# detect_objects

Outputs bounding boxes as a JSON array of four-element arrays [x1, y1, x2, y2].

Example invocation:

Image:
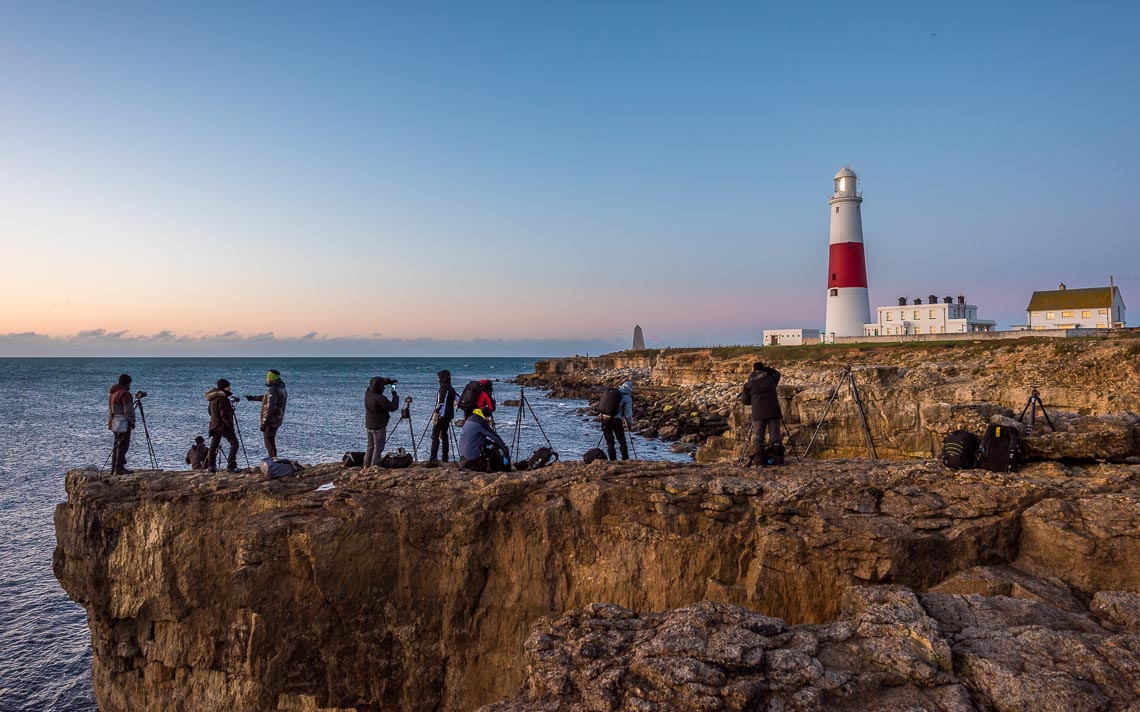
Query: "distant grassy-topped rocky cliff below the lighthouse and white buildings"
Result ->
[[520, 330, 1140, 463]]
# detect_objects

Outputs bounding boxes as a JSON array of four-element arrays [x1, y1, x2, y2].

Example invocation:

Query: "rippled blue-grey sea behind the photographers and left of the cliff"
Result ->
[[0, 358, 687, 712]]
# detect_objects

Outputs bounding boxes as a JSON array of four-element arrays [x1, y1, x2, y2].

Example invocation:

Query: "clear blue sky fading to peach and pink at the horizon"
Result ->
[[0, 1, 1140, 355]]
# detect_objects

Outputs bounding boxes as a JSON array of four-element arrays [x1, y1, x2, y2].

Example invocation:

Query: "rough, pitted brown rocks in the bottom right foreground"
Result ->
[[482, 587, 1140, 712]]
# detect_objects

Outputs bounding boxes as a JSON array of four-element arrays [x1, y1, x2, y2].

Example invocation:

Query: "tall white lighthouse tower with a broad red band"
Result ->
[[824, 166, 871, 341]]
